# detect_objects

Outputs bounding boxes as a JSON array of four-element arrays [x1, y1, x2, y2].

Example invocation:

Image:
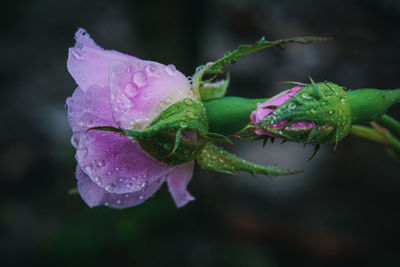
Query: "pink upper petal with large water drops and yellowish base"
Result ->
[[110, 59, 194, 129]]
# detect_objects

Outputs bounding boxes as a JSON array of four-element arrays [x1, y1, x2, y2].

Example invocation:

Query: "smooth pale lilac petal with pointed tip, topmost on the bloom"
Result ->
[[67, 29, 135, 91]]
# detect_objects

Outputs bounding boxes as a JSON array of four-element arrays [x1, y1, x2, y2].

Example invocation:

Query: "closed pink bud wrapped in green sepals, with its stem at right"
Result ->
[[251, 80, 400, 149]]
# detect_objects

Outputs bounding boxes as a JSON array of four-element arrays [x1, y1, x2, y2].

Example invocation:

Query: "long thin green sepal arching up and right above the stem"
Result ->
[[192, 36, 332, 100]]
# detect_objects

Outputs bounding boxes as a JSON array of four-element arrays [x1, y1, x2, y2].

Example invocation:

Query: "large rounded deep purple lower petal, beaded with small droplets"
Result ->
[[76, 130, 174, 194]]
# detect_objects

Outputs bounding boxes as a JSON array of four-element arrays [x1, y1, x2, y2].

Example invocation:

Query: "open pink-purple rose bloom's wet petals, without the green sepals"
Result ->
[[67, 29, 194, 209]]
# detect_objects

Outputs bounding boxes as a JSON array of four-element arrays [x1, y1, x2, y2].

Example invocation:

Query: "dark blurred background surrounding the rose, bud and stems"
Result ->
[[0, 0, 400, 266]]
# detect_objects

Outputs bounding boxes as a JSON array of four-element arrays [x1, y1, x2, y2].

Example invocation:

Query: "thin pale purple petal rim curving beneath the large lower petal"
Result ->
[[76, 165, 165, 209]]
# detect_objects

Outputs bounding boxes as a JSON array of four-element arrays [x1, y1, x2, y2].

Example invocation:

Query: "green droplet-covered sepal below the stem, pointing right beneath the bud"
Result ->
[[196, 142, 300, 176]]
